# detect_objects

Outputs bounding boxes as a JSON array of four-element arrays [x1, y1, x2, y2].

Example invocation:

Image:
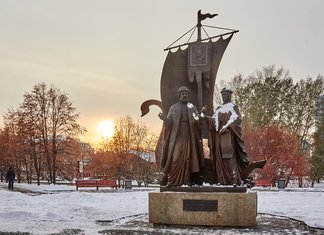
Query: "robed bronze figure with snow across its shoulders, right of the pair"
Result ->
[[208, 88, 265, 185]]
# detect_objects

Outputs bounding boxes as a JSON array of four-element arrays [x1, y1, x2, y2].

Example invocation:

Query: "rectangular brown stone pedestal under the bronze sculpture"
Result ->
[[149, 192, 257, 227]]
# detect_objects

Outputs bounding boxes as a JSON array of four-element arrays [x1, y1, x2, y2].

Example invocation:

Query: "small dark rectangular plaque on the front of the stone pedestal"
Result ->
[[183, 199, 218, 211]]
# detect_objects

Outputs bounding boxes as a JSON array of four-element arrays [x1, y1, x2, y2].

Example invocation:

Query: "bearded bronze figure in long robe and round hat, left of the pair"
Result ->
[[158, 86, 204, 186]]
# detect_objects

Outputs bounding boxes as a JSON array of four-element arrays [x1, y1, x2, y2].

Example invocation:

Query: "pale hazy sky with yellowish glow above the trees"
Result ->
[[0, 0, 324, 142]]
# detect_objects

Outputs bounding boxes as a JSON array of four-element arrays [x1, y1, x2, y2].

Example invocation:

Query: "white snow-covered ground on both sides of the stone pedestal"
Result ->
[[0, 183, 324, 234]]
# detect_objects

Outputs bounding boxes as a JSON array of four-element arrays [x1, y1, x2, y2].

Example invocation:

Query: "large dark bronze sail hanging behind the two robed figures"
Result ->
[[160, 34, 233, 119]]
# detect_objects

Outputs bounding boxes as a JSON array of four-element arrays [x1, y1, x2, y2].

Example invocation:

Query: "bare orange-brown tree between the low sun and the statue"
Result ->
[[90, 116, 158, 184]]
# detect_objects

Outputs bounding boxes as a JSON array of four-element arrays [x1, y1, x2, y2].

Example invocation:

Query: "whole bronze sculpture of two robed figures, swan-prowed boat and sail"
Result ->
[[141, 11, 265, 186]]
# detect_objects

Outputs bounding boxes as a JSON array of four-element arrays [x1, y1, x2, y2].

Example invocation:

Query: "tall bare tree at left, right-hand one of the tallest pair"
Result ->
[[23, 83, 85, 184]]
